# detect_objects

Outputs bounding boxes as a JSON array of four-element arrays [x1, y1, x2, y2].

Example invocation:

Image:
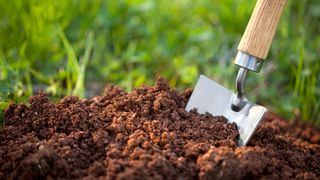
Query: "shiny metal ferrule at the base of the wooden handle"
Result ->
[[234, 51, 263, 72]]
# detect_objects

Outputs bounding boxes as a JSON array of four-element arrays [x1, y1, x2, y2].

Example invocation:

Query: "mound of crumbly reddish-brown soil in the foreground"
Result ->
[[0, 79, 320, 179]]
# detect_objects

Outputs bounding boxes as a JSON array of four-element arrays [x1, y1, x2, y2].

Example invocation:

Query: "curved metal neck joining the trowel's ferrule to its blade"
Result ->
[[231, 67, 248, 112]]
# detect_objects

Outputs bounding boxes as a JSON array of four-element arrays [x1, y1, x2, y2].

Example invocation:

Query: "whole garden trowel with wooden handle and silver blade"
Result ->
[[186, 0, 287, 146]]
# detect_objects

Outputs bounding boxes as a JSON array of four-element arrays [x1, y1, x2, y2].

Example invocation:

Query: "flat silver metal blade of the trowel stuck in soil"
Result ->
[[186, 75, 267, 146]]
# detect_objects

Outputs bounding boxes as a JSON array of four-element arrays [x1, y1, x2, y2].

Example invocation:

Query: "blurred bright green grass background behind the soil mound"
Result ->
[[0, 0, 320, 125]]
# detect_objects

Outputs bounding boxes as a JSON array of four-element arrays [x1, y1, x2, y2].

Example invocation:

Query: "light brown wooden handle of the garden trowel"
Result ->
[[238, 0, 287, 59]]
